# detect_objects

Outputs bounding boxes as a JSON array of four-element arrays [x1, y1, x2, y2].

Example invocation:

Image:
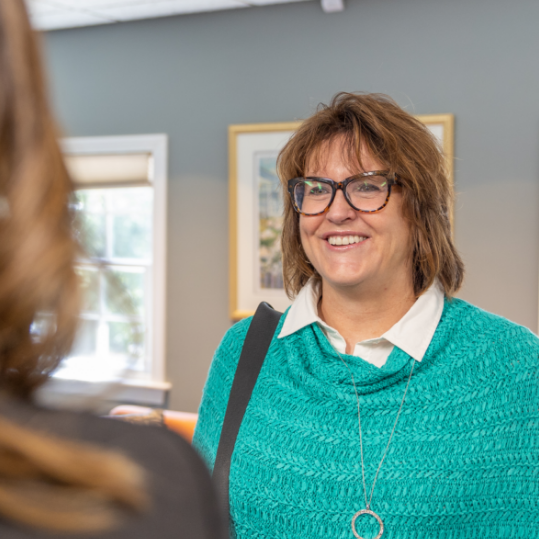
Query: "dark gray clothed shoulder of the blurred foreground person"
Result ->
[[0, 403, 224, 539]]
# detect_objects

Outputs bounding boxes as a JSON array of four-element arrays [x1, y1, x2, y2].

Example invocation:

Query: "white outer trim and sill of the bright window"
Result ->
[[43, 134, 171, 406]]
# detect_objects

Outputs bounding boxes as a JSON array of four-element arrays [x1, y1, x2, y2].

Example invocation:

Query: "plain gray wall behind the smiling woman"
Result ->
[[45, 0, 539, 411]]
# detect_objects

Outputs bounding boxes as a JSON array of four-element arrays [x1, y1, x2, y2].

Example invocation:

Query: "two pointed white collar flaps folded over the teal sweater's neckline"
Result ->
[[279, 279, 444, 361]]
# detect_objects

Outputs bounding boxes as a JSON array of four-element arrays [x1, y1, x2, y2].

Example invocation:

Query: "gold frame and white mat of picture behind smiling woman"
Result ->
[[228, 114, 454, 320]]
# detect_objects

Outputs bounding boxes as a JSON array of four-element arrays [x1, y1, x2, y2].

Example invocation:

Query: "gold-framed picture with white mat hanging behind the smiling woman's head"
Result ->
[[228, 114, 454, 320]]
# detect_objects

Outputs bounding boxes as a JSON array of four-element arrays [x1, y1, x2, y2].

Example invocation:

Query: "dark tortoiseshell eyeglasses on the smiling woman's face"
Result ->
[[288, 170, 398, 215]]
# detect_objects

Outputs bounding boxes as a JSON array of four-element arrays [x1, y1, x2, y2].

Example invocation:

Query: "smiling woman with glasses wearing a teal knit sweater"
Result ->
[[194, 90, 539, 539]]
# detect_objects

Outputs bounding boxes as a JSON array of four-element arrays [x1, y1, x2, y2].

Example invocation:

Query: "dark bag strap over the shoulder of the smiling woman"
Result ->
[[213, 302, 282, 518]]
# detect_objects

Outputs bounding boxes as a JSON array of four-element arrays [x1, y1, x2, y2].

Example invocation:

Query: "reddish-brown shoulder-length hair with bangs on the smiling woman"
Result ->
[[278, 92, 464, 298]]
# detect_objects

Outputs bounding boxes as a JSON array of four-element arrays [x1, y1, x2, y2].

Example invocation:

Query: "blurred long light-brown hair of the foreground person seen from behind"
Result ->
[[0, 0, 146, 532]]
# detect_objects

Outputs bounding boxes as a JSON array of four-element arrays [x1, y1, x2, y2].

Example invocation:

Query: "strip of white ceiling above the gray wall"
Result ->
[[27, 0, 316, 30]]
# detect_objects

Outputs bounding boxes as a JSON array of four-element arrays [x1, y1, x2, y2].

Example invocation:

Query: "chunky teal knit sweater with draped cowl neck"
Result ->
[[194, 299, 539, 539]]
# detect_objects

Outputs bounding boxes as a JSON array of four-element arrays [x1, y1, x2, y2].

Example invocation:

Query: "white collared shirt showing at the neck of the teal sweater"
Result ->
[[279, 279, 444, 367]]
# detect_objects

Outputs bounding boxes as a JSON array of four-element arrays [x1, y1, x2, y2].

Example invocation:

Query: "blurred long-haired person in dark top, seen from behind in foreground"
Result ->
[[0, 0, 226, 539]]
